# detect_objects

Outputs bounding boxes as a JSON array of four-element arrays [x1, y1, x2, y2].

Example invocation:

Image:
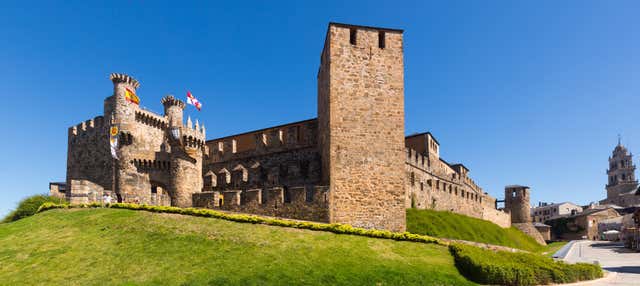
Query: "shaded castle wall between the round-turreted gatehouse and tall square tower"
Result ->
[[203, 119, 321, 191]]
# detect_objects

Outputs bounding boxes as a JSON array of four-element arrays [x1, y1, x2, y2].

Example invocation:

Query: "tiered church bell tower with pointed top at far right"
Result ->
[[606, 139, 638, 204]]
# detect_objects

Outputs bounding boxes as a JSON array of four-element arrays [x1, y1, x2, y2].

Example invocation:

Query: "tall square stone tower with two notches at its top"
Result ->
[[318, 23, 406, 231]]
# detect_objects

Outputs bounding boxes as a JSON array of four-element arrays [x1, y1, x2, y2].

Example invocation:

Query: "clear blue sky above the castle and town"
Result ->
[[0, 1, 640, 215]]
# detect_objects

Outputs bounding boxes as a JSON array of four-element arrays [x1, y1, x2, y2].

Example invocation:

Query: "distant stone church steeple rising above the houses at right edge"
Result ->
[[600, 139, 640, 207]]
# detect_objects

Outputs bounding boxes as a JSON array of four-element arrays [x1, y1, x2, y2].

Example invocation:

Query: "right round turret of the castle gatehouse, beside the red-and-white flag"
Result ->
[[162, 95, 205, 207]]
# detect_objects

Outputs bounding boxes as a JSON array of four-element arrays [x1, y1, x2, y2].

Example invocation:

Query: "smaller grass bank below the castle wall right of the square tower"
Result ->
[[407, 209, 546, 252]]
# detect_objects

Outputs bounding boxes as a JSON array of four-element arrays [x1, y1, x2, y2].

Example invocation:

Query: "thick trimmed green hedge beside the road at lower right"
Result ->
[[449, 244, 603, 285]]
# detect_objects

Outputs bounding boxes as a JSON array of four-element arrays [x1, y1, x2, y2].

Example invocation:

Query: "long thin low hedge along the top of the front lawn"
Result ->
[[38, 203, 448, 245]]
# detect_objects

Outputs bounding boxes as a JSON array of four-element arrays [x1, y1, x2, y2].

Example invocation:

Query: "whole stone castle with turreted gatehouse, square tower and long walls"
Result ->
[[50, 23, 510, 231]]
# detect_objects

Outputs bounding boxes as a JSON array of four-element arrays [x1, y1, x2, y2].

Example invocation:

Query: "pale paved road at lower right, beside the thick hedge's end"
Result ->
[[564, 241, 640, 286]]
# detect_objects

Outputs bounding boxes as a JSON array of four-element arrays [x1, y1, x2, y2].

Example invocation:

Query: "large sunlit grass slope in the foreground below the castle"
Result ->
[[0, 209, 473, 285]]
